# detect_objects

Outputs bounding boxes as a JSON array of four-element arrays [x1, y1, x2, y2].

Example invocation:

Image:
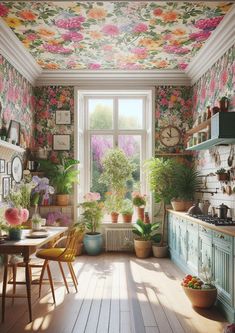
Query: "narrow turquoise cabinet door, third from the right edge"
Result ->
[[187, 222, 198, 275]]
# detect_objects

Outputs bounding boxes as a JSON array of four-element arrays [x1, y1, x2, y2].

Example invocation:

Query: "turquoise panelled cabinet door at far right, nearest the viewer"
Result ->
[[213, 235, 233, 305]]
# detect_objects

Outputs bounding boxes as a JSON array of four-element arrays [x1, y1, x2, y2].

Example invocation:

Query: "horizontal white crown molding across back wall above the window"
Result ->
[[36, 70, 191, 88]]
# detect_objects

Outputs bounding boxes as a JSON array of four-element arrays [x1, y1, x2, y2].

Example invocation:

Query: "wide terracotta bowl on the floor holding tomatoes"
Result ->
[[183, 287, 217, 308]]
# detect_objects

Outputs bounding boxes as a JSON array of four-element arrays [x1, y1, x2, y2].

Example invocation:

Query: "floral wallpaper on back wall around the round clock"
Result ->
[[155, 86, 193, 153]]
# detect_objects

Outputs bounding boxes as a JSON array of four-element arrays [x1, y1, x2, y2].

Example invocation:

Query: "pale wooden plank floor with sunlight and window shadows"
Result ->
[[0, 254, 226, 333]]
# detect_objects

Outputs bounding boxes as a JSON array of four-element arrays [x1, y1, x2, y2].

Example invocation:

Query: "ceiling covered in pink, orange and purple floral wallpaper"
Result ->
[[0, 1, 232, 70]]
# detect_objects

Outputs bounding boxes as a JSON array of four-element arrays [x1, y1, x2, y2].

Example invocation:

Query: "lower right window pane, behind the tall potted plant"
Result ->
[[118, 135, 141, 197]]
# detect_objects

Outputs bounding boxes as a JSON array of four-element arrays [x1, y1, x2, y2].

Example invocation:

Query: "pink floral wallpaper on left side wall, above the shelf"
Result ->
[[0, 54, 35, 147]]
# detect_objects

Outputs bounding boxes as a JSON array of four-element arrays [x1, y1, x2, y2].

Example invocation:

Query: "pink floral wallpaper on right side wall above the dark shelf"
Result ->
[[192, 45, 235, 116]]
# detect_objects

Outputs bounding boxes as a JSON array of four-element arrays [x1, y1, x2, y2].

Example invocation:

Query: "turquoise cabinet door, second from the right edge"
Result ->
[[198, 231, 212, 279]]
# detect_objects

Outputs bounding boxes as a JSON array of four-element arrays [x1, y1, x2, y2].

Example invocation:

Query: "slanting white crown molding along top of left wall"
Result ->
[[0, 18, 42, 85]]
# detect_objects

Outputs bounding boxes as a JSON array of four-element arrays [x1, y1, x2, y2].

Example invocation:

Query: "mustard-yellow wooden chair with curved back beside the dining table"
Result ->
[[36, 228, 82, 302]]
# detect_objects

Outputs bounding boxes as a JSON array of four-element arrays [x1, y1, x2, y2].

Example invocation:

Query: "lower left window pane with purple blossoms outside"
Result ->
[[90, 135, 113, 199]]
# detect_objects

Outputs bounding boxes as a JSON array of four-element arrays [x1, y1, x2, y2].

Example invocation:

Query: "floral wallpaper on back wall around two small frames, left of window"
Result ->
[[35, 86, 74, 159]]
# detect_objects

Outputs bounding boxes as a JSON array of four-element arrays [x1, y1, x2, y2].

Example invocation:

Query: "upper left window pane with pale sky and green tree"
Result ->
[[88, 98, 113, 130]]
